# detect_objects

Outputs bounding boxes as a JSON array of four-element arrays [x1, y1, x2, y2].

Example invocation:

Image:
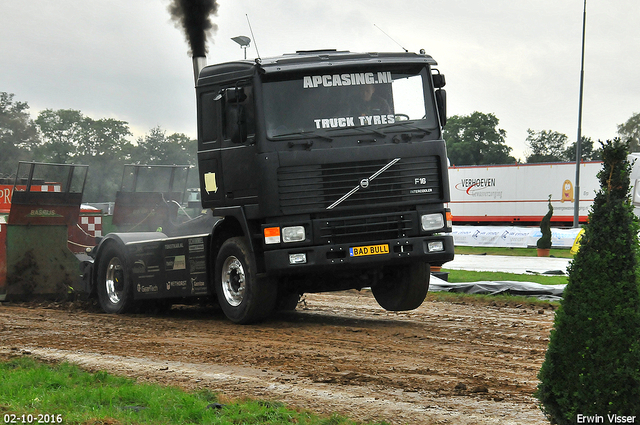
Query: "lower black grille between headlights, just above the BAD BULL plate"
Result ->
[[315, 211, 418, 244]]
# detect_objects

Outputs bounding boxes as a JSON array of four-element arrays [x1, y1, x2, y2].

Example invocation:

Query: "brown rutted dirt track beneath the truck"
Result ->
[[0, 291, 553, 424]]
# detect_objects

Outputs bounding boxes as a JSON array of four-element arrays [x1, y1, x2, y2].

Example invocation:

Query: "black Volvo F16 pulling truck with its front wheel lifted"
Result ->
[[86, 50, 454, 323]]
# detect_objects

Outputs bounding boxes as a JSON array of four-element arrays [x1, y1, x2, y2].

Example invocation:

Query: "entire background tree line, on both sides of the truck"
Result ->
[[0, 92, 640, 202]]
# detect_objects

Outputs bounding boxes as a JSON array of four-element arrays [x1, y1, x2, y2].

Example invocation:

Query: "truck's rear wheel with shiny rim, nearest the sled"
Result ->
[[96, 244, 134, 314]]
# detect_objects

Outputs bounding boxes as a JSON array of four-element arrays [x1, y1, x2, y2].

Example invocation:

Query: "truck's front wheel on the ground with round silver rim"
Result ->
[[214, 237, 277, 325]]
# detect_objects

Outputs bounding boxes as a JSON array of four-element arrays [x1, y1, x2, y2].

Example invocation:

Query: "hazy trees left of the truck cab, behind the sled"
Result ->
[[0, 92, 197, 202]]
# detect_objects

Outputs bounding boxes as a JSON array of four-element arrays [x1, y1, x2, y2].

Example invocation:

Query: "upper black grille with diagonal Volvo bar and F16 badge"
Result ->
[[278, 156, 442, 214]]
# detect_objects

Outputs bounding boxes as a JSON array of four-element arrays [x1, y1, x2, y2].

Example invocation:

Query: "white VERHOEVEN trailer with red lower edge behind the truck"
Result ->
[[449, 160, 604, 226]]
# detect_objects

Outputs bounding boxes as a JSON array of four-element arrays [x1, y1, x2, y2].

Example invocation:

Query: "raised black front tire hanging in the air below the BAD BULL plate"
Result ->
[[371, 263, 431, 311]]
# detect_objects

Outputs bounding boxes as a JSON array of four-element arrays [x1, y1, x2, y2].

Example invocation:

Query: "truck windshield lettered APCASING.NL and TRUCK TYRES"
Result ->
[[263, 67, 437, 138]]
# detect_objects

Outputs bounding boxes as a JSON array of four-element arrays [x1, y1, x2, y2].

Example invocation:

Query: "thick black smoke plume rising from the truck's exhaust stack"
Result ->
[[169, 0, 218, 56]]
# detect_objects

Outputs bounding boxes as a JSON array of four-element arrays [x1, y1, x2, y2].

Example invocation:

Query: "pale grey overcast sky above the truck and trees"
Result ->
[[0, 0, 640, 159]]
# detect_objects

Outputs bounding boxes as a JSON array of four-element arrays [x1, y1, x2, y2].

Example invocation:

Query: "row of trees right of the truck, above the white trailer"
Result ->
[[444, 111, 640, 165]]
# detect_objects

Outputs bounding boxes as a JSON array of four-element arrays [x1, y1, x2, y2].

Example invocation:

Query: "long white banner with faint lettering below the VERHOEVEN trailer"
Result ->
[[451, 226, 580, 248]]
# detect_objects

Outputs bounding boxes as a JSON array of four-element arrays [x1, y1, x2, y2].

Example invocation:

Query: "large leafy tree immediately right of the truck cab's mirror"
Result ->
[[444, 111, 515, 165]]
